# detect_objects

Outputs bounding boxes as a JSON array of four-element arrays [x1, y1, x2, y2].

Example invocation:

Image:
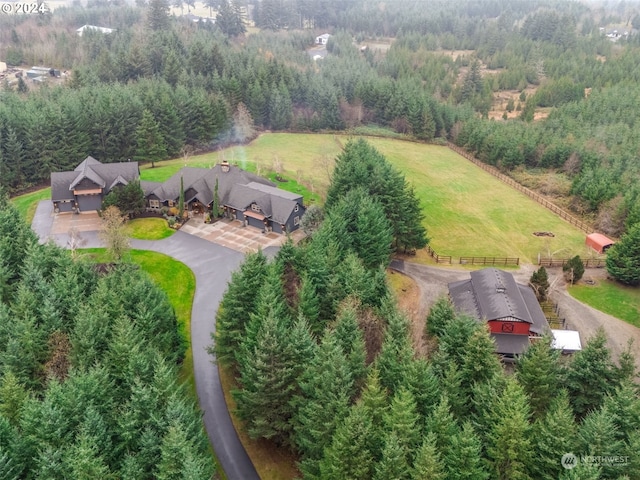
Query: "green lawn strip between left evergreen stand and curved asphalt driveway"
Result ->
[[82, 248, 196, 388]]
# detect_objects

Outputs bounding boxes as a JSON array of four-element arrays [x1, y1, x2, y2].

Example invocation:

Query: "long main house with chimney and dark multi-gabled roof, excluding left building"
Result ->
[[140, 162, 305, 233]]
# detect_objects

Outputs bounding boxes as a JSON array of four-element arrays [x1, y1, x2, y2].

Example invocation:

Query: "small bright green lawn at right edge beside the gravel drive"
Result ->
[[569, 280, 640, 327]]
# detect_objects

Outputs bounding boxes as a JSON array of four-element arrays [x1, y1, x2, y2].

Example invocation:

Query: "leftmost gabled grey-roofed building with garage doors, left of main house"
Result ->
[[51, 156, 140, 212]]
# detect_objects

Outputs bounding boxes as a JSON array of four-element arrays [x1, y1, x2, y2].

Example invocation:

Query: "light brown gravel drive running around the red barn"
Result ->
[[391, 260, 640, 369]]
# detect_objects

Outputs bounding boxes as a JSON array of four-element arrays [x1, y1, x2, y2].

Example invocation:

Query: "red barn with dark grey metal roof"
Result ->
[[449, 268, 551, 357]]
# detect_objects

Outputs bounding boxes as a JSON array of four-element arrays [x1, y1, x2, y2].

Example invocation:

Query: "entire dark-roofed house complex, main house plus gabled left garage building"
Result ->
[[51, 157, 305, 233]]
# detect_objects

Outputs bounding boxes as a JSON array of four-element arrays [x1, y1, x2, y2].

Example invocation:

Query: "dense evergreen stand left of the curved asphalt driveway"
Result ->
[[0, 192, 214, 479]]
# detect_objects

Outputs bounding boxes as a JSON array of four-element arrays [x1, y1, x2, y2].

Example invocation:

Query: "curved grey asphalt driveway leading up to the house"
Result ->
[[32, 201, 260, 480]]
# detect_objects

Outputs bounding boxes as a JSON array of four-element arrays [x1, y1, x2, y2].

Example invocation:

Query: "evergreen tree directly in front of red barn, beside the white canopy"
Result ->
[[516, 337, 561, 418]]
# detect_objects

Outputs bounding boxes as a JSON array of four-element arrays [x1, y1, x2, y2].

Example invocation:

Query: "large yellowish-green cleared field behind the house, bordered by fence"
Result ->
[[168, 133, 587, 263]]
